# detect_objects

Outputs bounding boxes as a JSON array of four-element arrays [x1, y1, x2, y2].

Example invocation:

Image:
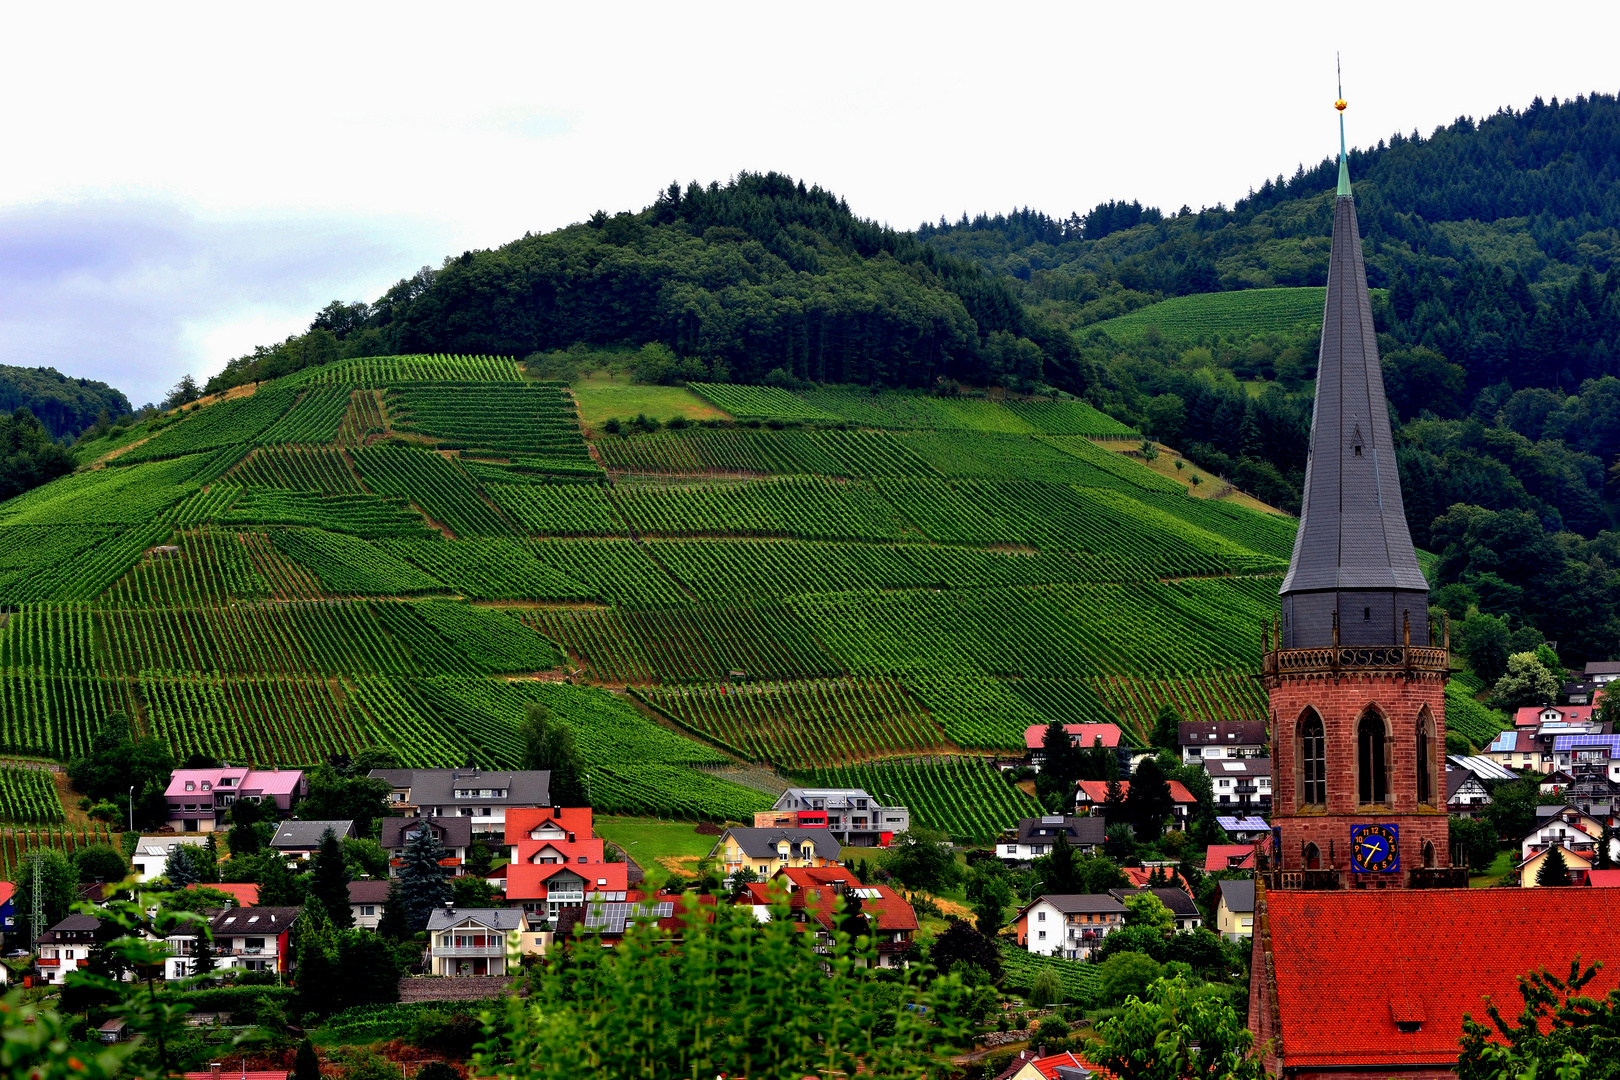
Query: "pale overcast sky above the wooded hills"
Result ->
[[0, 0, 1620, 403]]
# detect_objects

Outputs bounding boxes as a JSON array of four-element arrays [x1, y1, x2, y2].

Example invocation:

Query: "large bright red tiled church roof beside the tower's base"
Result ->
[[1265, 889, 1620, 1069]]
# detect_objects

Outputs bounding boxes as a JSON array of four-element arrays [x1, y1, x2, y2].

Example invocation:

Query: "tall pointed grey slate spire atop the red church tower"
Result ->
[[1280, 88, 1429, 649]]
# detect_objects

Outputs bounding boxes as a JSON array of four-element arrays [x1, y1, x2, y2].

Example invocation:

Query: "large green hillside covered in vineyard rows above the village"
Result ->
[[0, 356, 1293, 839]]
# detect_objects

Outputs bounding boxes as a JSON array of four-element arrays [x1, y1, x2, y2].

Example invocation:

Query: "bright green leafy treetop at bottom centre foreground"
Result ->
[[473, 902, 970, 1080]]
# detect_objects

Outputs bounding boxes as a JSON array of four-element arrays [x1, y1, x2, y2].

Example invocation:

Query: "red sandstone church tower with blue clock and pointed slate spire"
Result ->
[[1264, 100, 1455, 889]]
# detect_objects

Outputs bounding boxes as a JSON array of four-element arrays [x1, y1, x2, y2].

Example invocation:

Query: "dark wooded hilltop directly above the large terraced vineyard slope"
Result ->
[[209, 173, 1072, 390]]
